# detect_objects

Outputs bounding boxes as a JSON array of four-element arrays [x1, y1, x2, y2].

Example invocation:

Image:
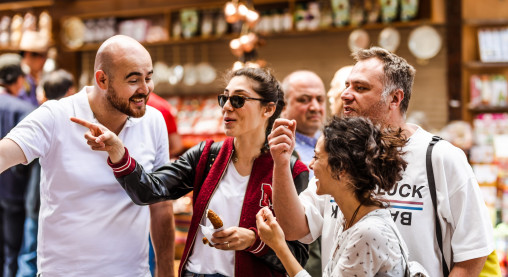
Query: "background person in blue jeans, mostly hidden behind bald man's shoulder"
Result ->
[[16, 69, 76, 277]]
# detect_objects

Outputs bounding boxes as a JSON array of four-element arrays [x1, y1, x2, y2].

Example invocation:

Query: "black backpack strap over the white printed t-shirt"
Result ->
[[426, 136, 450, 277]]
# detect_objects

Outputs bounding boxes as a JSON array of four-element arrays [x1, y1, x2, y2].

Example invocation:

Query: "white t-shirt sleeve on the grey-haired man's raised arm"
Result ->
[[298, 177, 325, 244]]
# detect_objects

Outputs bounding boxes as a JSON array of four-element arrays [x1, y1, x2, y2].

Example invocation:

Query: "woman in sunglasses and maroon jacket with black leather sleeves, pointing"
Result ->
[[71, 68, 308, 277]]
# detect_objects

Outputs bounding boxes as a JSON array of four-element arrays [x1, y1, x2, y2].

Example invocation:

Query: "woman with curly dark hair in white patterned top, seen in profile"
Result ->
[[257, 116, 407, 277]]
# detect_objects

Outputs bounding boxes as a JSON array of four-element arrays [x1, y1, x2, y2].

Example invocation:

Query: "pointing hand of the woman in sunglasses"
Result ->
[[71, 117, 125, 163]]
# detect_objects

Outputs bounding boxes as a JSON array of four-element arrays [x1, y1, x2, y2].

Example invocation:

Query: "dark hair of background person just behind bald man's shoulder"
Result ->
[[42, 69, 74, 100]]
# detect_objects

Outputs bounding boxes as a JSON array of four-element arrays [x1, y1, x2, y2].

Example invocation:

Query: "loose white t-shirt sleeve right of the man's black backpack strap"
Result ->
[[433, 142, 494, 262]]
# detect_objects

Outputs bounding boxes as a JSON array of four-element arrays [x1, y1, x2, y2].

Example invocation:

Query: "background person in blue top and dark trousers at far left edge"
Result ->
[[0, 54, 34, 277]]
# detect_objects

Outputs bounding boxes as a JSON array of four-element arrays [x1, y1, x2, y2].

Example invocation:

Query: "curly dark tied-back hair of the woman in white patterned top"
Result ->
[[323, 116, 407, 207]]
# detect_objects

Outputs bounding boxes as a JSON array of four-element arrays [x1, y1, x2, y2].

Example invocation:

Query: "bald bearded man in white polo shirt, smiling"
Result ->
[[0, 36, 174, 277]]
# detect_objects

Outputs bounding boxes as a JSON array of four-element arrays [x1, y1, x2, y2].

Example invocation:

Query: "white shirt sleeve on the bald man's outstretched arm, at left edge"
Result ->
[[5, 101, 56, 163]]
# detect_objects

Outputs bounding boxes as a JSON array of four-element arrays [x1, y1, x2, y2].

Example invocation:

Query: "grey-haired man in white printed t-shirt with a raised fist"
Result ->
[[269, 47, 494, 276]]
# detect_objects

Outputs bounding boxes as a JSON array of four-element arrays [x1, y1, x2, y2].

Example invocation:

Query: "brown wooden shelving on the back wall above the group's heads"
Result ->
[[0, 0, 449, 128]]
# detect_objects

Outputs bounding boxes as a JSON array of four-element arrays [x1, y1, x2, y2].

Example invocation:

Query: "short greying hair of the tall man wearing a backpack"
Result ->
[[352, 47, 416, 115]]
